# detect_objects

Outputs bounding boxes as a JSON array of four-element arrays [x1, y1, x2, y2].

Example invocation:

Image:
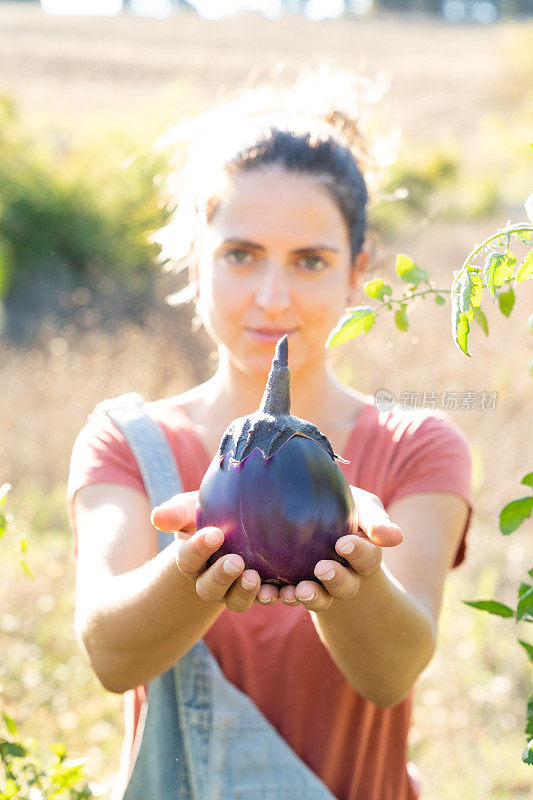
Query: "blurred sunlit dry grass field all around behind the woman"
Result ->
[[0, 3, 533, 800]]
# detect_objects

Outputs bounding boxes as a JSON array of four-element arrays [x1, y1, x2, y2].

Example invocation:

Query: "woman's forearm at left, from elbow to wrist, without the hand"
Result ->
[[76, 543, 224, 692]]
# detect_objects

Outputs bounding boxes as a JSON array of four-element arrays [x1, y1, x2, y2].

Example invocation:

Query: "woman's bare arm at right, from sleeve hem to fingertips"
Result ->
[[280, 489, 467, 707]]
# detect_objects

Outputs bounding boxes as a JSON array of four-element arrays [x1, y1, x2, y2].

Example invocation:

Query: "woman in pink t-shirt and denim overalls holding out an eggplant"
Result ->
[[69, 72, 472, 800]]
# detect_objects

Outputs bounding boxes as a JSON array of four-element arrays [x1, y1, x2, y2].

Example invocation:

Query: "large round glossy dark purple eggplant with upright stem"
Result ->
[[196, 335, 357, 586]]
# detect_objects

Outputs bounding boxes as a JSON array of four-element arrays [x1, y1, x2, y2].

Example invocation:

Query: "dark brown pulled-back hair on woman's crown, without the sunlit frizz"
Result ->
[[208, 127, 368, 259]]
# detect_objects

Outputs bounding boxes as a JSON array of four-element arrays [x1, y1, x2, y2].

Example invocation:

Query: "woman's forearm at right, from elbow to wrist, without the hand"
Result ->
[[311, 565, 436, 707]]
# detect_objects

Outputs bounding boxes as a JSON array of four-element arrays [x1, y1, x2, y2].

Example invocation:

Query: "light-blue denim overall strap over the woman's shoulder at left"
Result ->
[[93, 392, 183, 550]]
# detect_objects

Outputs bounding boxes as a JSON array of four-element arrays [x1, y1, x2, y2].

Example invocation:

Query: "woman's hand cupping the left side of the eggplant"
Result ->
[[151, 492, 278, 612]]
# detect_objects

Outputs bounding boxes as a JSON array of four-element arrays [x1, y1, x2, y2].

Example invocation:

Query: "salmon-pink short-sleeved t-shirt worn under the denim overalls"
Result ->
[[68, 398, 472, 800]]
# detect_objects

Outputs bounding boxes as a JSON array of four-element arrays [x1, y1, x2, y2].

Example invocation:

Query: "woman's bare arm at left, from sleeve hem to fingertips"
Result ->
[[74, 484, 260, 693]]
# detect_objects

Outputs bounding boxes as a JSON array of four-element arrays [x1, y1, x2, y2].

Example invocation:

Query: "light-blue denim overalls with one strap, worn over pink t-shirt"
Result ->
[[94, 392, 335, 800]]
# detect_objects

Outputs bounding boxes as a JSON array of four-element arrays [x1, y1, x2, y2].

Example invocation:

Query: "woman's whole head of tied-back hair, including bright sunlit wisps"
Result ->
[[151, 65, 387, 305]]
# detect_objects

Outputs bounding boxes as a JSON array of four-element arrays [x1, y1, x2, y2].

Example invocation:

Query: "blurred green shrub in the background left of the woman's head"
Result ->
[[0, 97, 165, 304]]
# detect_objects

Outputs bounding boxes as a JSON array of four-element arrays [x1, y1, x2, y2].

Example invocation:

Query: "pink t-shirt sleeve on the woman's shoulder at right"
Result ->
[[387, 414, 473, 567]]
